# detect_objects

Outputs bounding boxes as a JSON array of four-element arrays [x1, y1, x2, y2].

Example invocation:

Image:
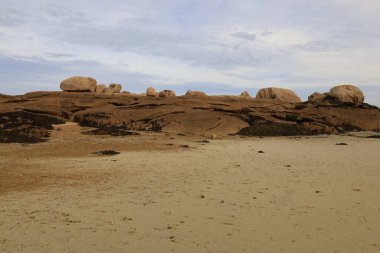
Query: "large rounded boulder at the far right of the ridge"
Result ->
[[329, 84, 364, 104]]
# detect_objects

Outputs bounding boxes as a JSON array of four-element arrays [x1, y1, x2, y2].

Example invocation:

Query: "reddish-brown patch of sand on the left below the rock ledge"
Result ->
[[0, 123, 201, 194]]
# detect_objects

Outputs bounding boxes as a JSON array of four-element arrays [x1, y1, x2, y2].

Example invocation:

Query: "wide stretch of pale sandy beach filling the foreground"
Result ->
[[0, 124, 380, 253]]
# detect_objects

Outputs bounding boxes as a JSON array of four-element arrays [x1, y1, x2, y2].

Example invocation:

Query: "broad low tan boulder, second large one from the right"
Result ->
[[256, 87, 302, 103]]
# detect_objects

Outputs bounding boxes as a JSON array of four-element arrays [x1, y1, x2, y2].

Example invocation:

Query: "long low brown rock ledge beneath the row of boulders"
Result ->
[[0, 92, 380, 142]]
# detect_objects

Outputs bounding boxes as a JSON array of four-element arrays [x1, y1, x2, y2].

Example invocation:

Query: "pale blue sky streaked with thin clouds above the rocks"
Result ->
[[0, 0, 380, 106]]
